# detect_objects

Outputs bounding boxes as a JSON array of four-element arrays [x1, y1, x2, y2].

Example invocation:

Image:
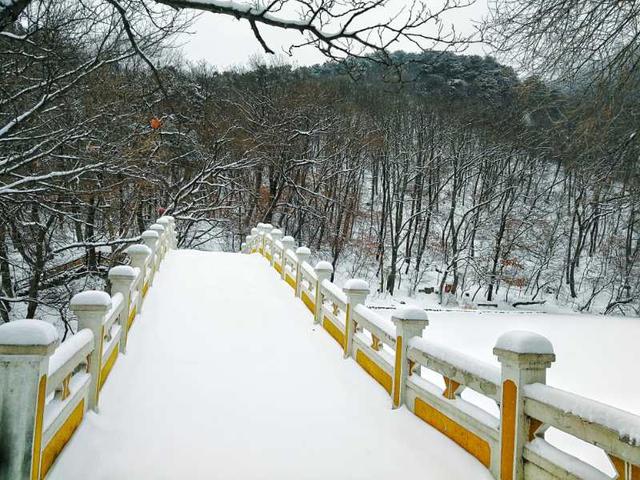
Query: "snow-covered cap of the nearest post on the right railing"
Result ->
[[493, 330, 556, 367]]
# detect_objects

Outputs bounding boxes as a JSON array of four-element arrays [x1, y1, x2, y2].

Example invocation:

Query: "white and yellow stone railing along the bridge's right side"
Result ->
[[242, 224, 640, 480]]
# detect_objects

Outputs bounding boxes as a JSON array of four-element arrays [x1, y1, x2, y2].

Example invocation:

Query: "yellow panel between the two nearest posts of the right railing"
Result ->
[[414, 398, 491, 468]]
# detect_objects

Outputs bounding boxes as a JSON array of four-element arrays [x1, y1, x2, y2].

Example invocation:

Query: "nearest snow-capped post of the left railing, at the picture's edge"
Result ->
[[0, 320, 58, 480]]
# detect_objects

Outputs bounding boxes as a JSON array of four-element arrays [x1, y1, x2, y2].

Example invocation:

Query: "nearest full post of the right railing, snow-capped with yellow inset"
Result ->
[[493, 331, 556, 480]]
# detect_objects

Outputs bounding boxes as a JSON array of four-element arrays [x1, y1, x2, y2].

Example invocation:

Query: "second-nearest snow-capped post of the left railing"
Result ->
[[69, 290, 111, 412]]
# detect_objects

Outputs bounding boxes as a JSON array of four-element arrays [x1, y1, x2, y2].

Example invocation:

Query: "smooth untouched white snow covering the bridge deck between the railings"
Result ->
[[47, 250, 491, 480]]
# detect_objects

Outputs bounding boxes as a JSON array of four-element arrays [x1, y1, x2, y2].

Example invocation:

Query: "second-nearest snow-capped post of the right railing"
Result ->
[[391, 307, 429, 408]]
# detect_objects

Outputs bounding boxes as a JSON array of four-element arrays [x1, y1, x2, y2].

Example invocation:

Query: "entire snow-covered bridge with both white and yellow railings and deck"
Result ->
[[0, 221, 640, 480]]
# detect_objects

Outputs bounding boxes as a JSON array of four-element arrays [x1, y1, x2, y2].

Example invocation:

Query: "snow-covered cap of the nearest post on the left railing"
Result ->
[[0, 319, 60, 356]]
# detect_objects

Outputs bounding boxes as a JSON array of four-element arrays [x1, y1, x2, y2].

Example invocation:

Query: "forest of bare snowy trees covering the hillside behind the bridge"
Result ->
[[0, 0, 640, 330]]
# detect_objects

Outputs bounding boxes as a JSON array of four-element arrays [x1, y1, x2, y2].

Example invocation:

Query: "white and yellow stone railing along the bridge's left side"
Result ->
[[0, 217, 176, 480]]
